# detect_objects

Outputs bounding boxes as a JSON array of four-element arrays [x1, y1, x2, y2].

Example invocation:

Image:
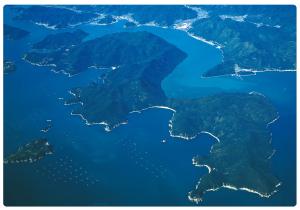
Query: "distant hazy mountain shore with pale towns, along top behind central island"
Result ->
[[15, 5, 197, 29]]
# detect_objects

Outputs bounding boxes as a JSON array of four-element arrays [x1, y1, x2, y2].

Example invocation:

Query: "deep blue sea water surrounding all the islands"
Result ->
[[4, 6, 296, 205]]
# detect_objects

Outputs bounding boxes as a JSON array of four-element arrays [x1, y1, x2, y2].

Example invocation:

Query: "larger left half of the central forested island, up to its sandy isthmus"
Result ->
[[25, 31, 186, 128]]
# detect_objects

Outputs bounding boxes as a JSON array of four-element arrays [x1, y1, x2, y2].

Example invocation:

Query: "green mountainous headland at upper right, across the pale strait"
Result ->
[[188, 6, 296, 77]]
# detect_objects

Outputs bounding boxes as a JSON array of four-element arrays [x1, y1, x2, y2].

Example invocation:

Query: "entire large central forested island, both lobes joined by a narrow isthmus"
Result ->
[[24, 30, 280, 202]]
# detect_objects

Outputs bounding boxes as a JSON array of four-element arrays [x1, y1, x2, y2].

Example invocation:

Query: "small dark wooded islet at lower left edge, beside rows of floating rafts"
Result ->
[[4, 139, 53, 164]]
